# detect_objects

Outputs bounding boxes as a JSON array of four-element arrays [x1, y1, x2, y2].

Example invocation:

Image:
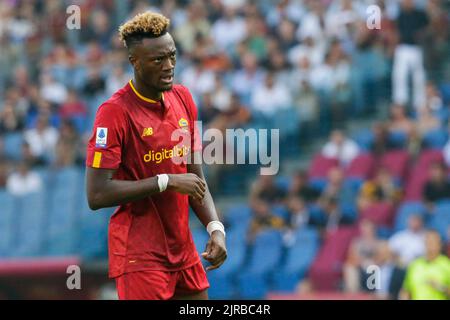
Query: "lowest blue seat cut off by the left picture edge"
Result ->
[[0, 191, 17, 258]]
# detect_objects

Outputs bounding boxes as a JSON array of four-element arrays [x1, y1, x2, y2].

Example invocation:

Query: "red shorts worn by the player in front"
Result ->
[[116, 262, 209, 300]]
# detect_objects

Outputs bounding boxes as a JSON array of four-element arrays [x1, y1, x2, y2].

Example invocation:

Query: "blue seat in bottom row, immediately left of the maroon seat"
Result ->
[[271, 228, 319, 292]]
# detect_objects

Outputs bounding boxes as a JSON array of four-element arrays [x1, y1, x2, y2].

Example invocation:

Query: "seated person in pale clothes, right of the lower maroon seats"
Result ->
[[344, 220, 381, 293]]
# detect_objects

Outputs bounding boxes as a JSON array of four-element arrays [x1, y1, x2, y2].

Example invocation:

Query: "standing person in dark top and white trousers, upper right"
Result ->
[[392, 0, 429, 110]]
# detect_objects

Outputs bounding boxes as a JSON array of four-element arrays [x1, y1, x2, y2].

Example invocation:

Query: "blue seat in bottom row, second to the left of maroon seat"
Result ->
[[237, 230, 282, 299]]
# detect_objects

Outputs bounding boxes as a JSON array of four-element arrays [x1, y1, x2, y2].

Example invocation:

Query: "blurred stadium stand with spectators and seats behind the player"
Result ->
[[0, 0, 450, 299]]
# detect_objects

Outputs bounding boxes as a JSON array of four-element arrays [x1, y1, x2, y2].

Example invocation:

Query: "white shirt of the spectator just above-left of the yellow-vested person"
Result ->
[[389, 230, 425, 265]]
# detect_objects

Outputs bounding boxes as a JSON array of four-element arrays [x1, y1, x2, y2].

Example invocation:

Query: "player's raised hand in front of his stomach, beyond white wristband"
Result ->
[[167, 173, 206, 201]]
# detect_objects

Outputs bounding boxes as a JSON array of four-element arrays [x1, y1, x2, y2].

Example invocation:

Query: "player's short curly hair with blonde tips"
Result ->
[[119, 11, 170, 45]]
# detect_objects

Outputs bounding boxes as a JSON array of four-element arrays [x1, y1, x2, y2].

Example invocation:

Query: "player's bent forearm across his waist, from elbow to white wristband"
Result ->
[[89, 177, 159, 210]]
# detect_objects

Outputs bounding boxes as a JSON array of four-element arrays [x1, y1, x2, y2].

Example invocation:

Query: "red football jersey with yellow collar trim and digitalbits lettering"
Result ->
[[86, 81, 201, 278]]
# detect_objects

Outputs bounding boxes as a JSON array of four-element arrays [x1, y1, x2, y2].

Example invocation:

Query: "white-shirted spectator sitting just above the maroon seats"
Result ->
[[322, 130, 359, 166]]
